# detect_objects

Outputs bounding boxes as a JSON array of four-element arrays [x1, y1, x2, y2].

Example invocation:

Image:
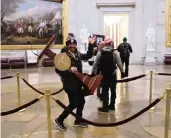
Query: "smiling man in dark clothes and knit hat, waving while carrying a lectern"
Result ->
[[54, 34, 95, 131]]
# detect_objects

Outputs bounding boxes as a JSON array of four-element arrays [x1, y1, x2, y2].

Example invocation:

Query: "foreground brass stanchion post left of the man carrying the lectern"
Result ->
[[46, 89, 52, 138]]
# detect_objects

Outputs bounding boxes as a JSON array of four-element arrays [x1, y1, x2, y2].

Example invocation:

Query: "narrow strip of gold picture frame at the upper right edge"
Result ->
[[166, 0, 171, 48]]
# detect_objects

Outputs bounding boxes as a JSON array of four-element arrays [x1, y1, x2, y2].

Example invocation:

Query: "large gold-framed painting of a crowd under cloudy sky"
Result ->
[[1, 0, 67, 50]]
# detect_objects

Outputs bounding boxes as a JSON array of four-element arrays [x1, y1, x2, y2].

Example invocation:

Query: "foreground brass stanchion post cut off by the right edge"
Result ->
[[164, 88, 171, 138]]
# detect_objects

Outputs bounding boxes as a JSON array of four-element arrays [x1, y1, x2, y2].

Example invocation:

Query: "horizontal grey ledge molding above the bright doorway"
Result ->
[[96, 2, 136, 8]]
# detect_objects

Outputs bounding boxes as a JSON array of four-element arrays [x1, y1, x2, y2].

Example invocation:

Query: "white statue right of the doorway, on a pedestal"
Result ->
[[145, 24, 155, 50]]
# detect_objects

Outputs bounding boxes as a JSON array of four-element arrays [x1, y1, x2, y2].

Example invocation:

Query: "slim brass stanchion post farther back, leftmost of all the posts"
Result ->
[[16, 72, 26, 112]]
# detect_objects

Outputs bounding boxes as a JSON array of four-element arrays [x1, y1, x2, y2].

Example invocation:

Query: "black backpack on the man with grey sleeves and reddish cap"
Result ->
[[99, 51, 116, 76]]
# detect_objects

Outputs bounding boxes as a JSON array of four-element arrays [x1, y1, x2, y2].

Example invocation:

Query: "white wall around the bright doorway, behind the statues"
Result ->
[[68, 0, 171, 63]]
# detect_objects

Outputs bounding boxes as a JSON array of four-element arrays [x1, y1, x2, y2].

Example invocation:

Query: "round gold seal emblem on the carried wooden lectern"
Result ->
[[54, 53, 71, 71]]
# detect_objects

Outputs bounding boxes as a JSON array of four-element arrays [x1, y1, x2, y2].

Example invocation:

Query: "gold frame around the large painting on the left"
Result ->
[[1, 0, 68, 50]]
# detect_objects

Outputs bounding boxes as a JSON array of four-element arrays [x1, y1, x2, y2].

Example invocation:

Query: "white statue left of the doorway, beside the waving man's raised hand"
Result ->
[[80, 24, 89, 51]]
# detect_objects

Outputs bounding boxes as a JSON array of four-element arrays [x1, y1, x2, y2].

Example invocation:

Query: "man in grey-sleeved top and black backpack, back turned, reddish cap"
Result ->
[[92, 39, 124, 112]]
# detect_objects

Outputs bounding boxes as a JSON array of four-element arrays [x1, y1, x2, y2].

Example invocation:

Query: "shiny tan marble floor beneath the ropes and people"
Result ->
[[1, 63, 171, 138]]
